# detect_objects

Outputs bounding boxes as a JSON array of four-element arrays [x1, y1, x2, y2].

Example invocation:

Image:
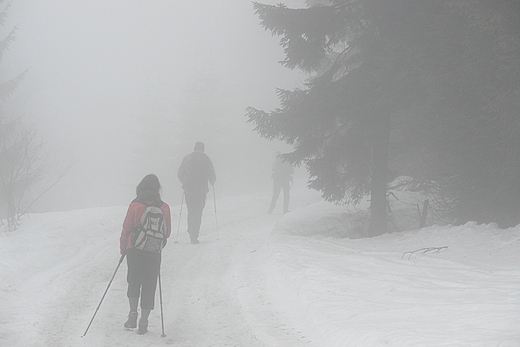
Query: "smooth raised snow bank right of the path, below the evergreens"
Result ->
[[266, 203, 520, 346]]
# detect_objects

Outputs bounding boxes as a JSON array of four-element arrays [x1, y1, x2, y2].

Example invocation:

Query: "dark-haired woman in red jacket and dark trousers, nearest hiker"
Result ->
[[120, 174, 171, 334]]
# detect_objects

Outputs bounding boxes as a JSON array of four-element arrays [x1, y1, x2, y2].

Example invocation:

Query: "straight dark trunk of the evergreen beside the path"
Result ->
[[368, 115, 390, 237]]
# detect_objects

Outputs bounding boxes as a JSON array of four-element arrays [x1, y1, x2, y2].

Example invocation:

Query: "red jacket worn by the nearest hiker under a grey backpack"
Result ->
[[119, 201, 172, 254]]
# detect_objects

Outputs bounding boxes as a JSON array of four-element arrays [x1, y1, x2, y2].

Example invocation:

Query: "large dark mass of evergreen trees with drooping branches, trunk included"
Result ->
[[247, 0, 520, 235]]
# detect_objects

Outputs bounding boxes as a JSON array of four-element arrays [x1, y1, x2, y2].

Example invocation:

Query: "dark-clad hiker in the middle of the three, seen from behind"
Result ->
[[177, 142, 216, 244]]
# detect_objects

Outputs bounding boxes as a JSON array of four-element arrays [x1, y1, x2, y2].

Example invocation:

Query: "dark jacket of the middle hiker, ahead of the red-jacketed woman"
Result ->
[[177, 151, 216, 193]]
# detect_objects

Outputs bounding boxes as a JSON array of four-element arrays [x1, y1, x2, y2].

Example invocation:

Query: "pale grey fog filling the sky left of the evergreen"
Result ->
[[9, 0, 304, 211]]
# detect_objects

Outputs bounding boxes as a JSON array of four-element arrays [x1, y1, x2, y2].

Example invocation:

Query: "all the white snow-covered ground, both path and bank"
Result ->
[[0, 185, 520, 347]]
